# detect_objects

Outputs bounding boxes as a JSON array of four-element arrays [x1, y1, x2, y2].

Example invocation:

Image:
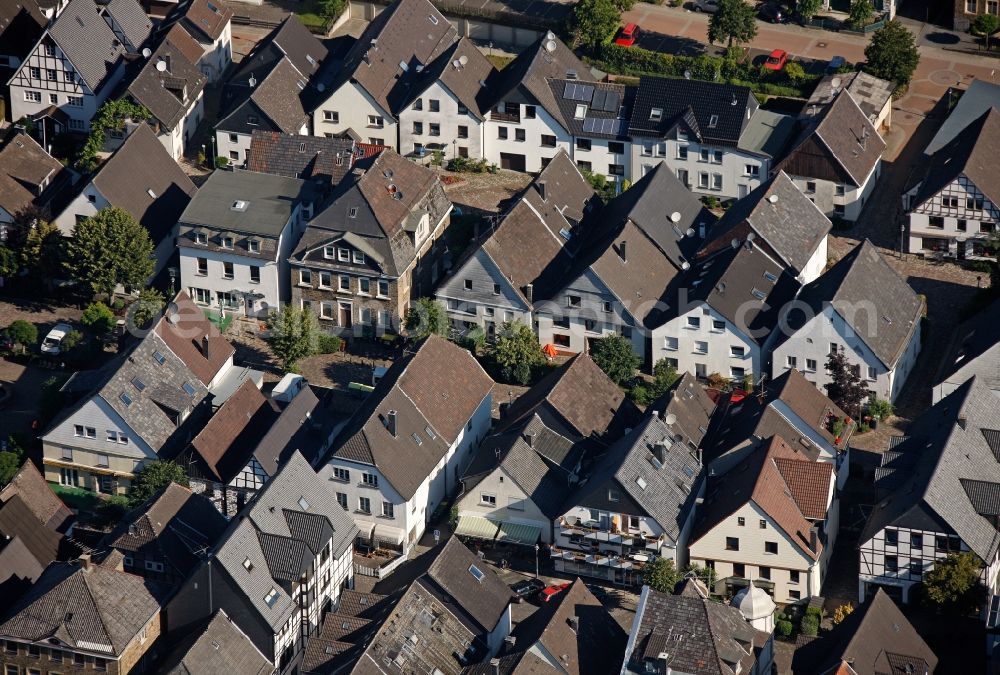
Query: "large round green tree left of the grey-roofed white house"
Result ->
[[67, 206, 155, 299]]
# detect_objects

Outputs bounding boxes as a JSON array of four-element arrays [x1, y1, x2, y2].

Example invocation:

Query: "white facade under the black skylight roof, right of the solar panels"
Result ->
[[631, 129, 771, 199]]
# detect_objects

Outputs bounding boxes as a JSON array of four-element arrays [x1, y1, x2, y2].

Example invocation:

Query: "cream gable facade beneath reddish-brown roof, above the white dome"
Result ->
[[690, 502, 835, 603]]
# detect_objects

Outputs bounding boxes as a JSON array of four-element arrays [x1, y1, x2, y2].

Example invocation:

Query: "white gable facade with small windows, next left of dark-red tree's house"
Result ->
[[651, 302, 765, 381]]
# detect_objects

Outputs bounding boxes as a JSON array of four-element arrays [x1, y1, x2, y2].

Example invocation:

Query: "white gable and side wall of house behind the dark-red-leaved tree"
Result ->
[[771, 303, 921, 401]]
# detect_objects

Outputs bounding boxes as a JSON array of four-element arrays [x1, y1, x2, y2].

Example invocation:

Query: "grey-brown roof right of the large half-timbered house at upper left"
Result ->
[[126, 39, 208, 131]]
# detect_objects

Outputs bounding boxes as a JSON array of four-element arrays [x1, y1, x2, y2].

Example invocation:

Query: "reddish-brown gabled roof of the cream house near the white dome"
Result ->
[[691, 436, 833, 560]]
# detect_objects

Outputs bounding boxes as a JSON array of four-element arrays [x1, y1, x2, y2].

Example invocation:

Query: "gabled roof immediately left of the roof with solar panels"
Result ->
[[482, 32, 596, 123]]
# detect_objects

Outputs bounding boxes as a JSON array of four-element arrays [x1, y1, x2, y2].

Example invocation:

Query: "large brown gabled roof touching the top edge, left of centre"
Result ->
[[328, 0, 464, 115]]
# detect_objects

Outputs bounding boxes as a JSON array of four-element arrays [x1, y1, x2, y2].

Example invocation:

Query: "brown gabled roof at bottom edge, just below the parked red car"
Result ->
[[508, 577, 628, 675]]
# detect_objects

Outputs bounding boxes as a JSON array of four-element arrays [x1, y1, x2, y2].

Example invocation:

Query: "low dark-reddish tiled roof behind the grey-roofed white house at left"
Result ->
[[247, 129, 355, 185]]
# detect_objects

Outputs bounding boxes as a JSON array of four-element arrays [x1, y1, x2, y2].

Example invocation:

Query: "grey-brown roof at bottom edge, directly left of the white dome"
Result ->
[[626, 586, 770, 675]]
